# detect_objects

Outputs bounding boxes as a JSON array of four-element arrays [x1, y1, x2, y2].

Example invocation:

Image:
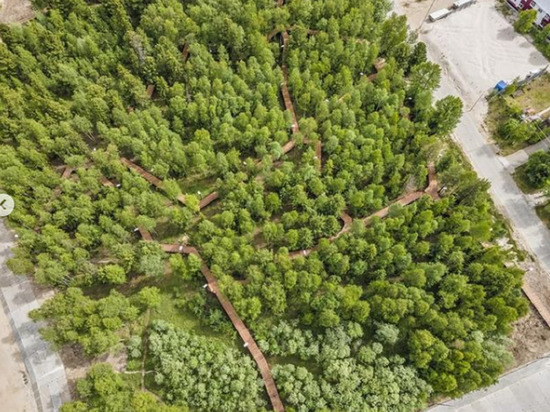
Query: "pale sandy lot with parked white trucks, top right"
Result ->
[[396, 0, 548, 111]]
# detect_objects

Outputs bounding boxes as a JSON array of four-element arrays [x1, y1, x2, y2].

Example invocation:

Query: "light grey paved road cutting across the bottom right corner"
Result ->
[[426, 357, 550, 412]]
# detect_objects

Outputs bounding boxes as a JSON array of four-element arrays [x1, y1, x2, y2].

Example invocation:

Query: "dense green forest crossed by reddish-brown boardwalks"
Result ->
[[0, 0, 527, 412]]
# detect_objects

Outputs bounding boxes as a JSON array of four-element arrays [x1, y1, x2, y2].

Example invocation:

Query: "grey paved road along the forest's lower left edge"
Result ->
[[0, 224, 69, 411]]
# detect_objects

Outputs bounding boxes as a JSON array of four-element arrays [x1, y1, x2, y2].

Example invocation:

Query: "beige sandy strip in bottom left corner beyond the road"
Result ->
[[0, 300, 37, 412]]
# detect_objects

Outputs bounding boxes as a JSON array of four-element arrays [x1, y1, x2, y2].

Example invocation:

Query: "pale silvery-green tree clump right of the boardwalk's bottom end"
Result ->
[[267, 325, 431, 411]]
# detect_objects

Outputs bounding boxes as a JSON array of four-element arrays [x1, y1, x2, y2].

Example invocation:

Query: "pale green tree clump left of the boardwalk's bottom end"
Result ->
[[149, 322, 266, 411]]
